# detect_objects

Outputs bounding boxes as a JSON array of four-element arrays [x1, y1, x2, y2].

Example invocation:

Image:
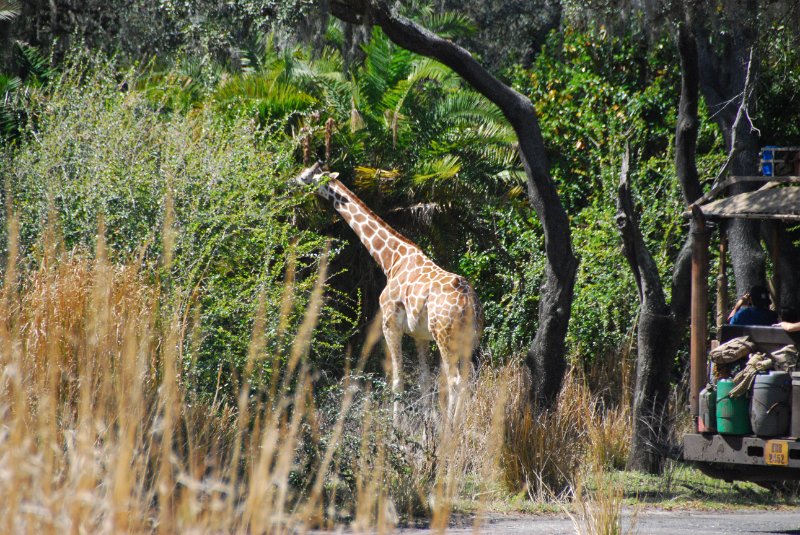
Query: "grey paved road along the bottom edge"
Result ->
[[400, 508, 800, 535]]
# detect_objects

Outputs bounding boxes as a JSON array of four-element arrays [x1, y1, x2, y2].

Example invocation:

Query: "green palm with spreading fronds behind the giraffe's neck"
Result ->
[[212, 18, 535, 354]]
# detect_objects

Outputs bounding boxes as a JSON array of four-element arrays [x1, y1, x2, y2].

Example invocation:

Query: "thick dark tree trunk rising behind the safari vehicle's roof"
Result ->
[[690, 0, 766, 295]]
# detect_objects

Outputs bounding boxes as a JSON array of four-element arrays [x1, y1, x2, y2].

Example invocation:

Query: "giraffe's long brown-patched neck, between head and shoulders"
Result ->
[[318, 179, 424, 277]]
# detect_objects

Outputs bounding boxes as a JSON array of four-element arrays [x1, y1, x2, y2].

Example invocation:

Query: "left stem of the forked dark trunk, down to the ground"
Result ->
[[616, 149, 678, 474]]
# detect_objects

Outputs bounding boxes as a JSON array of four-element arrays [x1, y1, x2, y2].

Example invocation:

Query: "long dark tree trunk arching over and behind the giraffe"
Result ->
[[331, 0, 578, 407]]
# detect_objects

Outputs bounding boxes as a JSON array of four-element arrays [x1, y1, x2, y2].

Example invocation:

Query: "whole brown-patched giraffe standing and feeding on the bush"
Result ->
[[295, 164, 483, 422]]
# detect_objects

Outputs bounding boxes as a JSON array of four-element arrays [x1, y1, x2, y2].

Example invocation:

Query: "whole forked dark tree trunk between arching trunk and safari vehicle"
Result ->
[[617, 16, 702, 473]]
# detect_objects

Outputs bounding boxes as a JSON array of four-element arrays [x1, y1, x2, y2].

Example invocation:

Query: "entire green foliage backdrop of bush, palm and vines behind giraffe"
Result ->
[[0, 6, 800, 392]]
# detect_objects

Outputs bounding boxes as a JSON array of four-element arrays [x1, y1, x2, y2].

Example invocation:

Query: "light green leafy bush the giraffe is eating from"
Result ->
[[2, 60, 352, 400]]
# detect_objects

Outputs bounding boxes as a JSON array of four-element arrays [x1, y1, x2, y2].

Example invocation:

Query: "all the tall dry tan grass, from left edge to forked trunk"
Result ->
[[0, 221, 629, 533]]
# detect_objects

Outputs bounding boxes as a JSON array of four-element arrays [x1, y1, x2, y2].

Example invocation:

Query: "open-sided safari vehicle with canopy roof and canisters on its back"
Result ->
[[683, 147, 800, 482]]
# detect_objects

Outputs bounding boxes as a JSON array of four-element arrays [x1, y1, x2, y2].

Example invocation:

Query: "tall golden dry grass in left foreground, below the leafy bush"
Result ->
[[0, 218, 406, 533]]
